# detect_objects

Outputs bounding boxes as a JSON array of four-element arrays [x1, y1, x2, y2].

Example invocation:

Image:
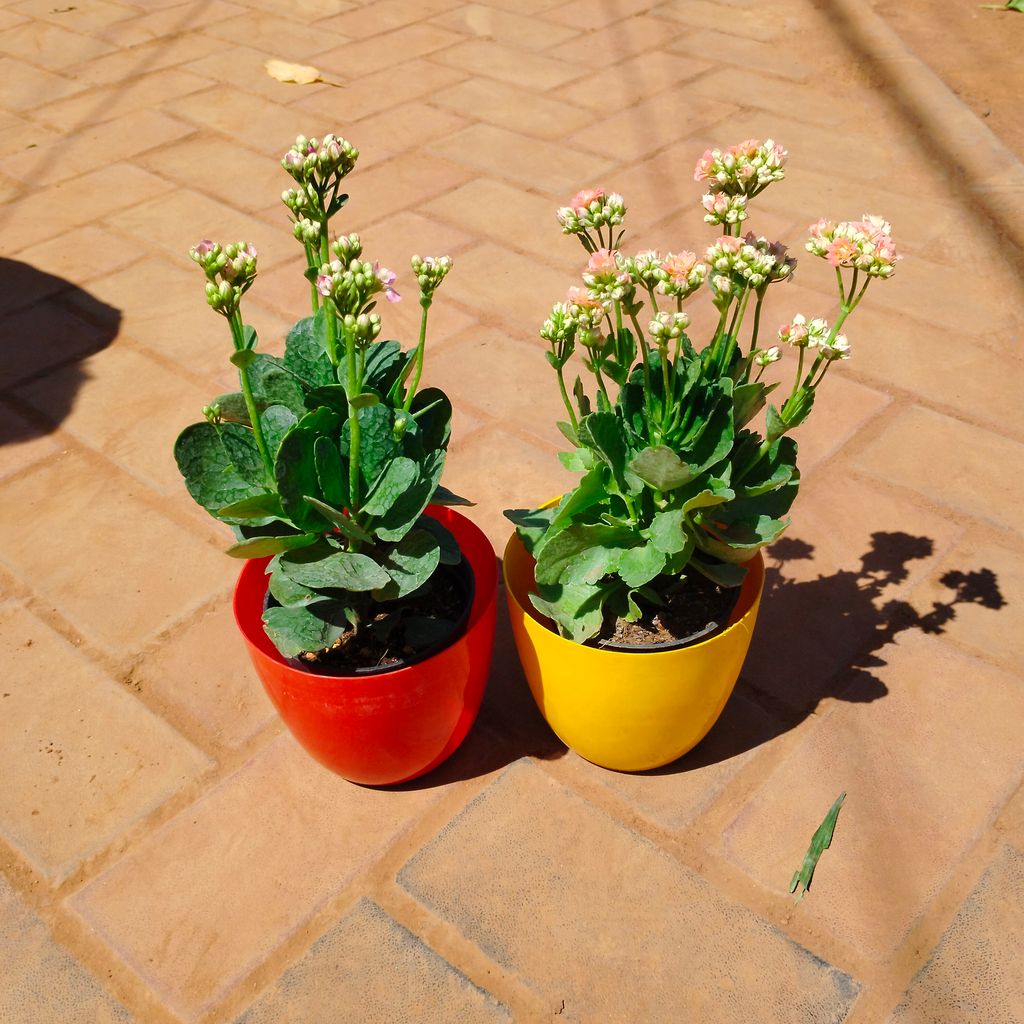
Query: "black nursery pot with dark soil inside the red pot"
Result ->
[[263, 556, 476, 677]]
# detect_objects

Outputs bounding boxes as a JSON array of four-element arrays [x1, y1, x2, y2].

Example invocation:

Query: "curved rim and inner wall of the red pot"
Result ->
[[231, 505, 498, 690]]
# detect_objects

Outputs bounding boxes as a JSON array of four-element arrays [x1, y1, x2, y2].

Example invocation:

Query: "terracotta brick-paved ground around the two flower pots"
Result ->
[[0, 0, 1024, 1024]]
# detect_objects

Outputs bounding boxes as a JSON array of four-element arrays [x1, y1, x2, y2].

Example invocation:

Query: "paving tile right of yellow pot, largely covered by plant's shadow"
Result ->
[[743, 466, 957, 709]]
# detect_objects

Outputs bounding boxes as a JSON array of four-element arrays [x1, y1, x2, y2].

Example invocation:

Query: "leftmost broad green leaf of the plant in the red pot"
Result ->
[[174, 423, 267, 515]]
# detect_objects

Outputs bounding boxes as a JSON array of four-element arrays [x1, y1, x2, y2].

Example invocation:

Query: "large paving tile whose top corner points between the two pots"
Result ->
[[398, 762, 858, 1024]]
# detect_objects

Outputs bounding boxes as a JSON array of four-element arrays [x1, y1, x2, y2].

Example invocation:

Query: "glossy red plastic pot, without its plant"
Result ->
[[234, 505, 498, 785]]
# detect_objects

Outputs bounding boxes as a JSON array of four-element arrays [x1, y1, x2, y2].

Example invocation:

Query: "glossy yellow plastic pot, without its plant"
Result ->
[[503, 516, 765, 771]]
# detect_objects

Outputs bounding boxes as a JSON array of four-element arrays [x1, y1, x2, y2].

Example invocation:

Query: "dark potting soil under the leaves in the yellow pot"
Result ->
[[587, 572, 740, 647]]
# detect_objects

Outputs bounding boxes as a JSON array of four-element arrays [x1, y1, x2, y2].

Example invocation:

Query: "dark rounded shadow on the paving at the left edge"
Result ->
[[0, 258, 121, 444]]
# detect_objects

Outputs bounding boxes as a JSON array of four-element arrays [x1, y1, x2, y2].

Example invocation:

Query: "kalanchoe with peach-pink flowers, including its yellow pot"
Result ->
[[505, 139, 899, 769]]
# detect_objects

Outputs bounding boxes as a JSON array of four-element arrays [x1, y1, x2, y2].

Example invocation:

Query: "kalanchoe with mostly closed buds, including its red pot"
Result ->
[[174, 135, 497, 783]]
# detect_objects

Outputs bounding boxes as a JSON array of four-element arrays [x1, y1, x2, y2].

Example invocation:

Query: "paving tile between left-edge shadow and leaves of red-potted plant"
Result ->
[[18, 345, 213, 494]]
